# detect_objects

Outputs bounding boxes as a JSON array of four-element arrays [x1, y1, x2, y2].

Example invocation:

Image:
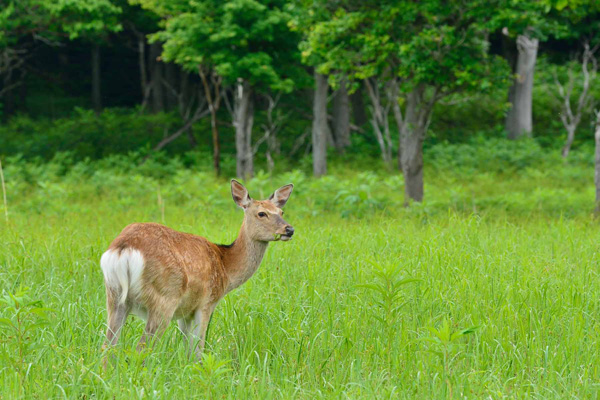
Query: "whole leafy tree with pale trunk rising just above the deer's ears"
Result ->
[[136, 0, 298, 178]]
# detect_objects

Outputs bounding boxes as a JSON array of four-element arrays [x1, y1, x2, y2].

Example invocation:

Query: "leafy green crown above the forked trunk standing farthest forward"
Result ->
[[301, 0, 508, 93]]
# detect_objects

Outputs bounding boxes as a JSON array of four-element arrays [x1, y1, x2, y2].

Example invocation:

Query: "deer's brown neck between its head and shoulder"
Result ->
[[223, 224, 269, 292]]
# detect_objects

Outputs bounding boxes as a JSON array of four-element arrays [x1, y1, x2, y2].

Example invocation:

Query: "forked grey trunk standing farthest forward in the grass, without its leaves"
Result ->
[[400, 85, 433, 205]]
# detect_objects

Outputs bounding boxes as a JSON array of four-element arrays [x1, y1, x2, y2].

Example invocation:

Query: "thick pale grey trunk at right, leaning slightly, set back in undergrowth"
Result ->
[[506, 35, 539, 139]]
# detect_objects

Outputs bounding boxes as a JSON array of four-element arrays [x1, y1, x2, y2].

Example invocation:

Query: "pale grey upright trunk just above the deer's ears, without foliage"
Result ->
[[233, 79, 254, 179]]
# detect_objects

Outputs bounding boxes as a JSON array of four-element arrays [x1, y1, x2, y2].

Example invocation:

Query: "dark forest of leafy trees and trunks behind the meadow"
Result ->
[[0, 0, 600, 202]]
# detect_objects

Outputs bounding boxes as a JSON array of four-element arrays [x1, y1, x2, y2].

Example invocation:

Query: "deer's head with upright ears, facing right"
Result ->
[[231, 179, 294, 242]]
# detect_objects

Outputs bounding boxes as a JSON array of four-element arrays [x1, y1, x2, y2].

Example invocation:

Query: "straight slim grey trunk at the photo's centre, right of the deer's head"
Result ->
[[312, 71, 330, 176]]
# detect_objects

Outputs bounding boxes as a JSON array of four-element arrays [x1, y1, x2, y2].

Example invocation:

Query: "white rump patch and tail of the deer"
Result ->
[[100, 249, 144, 304]]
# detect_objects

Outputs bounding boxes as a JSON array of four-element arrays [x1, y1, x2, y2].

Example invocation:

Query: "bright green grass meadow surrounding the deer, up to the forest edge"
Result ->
[[0, 152, 600, 400]]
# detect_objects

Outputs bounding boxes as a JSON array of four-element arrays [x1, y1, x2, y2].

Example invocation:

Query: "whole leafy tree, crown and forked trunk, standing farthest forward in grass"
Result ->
[[303, 0, 507, 202]]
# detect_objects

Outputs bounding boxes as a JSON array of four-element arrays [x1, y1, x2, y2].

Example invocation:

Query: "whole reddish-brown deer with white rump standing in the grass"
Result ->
[[100, 180, 294, 358]]
